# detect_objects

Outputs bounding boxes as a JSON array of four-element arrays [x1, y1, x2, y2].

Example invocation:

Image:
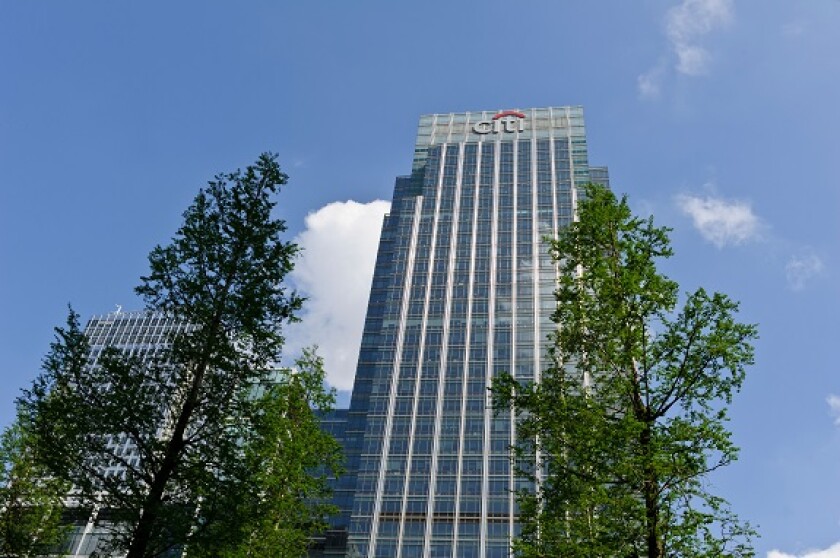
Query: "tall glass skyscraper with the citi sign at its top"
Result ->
[[337, 107, 607, 558]]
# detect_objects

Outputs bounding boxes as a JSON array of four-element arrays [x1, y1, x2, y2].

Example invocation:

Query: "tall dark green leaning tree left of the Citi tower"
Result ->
[[22, 154, 337, 558]]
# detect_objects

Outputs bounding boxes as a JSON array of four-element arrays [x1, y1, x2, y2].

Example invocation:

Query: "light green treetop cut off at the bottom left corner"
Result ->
[[0, 415, 67, 558]]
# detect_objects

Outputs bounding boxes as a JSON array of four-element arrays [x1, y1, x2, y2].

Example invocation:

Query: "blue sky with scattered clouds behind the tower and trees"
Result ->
[[0, 0, 840, 558]]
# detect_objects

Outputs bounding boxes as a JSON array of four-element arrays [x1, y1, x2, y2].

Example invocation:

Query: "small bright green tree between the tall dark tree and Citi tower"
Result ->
[[188, 350, 342, 558]]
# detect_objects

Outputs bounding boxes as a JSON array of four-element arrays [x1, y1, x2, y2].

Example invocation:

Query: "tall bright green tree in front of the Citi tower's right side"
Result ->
[[494, 185, 757, 558]]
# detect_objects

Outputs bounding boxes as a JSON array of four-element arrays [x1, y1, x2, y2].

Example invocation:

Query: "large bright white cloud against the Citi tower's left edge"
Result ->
[[286, 200, 390, 390]]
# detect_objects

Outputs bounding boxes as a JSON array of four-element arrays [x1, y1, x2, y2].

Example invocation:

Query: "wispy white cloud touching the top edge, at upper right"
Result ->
[[665, 0, 734, 76]]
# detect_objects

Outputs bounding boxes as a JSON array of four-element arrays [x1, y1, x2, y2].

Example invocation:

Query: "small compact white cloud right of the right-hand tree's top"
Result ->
[[676, 195, 762, 248]]
